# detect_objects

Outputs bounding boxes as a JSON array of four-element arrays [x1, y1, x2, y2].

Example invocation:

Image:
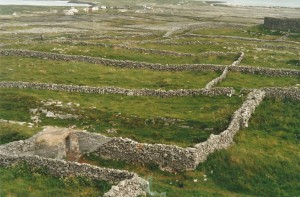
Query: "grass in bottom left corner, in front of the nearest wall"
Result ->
[[0, 164, 111, 197]]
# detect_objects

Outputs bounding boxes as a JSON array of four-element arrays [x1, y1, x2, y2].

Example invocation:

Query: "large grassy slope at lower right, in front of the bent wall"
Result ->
[[81, 99, 300, 197]]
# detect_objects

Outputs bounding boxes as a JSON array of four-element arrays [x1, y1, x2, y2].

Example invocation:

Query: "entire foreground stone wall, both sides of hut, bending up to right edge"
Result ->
[[0, 88, 300, 172]]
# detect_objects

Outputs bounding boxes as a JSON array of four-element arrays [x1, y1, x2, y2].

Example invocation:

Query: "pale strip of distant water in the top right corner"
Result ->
[[207, 0, 300, 8]]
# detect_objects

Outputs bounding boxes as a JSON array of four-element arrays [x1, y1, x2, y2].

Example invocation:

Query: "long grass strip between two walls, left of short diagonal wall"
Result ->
[[0, 57, 220, 89]]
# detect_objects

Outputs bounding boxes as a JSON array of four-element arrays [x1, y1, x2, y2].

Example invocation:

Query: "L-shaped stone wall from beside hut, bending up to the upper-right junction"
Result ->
[[97, 90, 265, 171]]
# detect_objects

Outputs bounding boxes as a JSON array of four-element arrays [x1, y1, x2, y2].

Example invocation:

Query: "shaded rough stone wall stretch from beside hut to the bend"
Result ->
[[97, 138, 197, 172]]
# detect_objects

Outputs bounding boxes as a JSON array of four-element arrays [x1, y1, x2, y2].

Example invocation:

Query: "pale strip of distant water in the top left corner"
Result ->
[[0, 0, 89, 6]]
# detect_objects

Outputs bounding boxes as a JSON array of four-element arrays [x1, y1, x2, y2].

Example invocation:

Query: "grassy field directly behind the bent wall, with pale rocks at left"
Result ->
[[0, 89, 242, 146]]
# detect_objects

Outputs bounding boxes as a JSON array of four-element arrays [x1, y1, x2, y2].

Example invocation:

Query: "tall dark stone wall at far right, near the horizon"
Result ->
[[264, 17, 300, 32]]
